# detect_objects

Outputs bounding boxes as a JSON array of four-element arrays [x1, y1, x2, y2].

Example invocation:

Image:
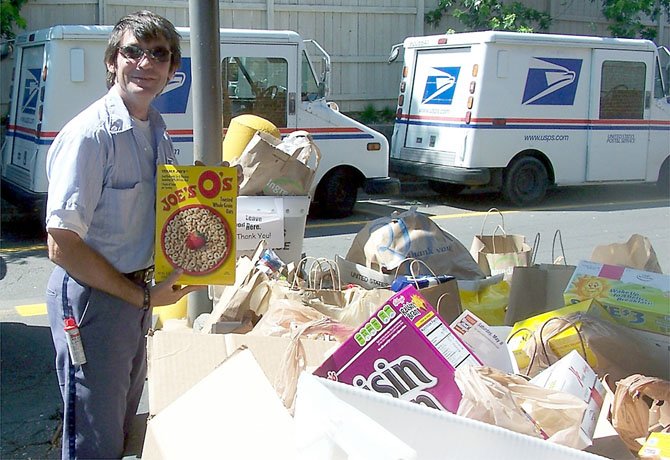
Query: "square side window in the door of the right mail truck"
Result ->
[[600, 61, 647, 119]]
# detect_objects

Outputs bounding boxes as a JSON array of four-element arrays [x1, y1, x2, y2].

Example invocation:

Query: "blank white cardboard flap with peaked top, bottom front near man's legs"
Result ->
[[142, 349, 297, 460]]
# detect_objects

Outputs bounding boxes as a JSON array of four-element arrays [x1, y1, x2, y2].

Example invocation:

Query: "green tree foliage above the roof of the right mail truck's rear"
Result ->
[[425, 0, 551, 32]]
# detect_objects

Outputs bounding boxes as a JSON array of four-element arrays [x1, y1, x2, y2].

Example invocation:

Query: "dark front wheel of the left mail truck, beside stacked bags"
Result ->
[[315, 169, 359, 218]]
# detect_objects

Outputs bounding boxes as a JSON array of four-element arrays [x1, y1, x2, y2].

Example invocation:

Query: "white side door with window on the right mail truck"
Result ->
[[586, 50, 654, 181]]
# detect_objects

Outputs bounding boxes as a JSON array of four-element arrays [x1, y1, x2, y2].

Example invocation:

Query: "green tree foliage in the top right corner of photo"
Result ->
[[591, 0, 670, 40]]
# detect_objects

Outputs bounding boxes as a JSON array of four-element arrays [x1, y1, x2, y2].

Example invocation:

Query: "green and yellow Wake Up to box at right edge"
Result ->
[[564, 260, 670, 335]]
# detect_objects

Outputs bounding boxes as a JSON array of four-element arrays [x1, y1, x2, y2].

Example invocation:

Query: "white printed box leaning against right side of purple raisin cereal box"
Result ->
[[451, 310, 519, 374]]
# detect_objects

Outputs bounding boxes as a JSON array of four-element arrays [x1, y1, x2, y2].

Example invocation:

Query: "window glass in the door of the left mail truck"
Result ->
[[221, 56, 288, 128]]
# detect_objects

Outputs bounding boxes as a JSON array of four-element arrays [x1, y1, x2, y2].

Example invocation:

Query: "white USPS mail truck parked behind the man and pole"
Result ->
[[2, 25, 399, 217]]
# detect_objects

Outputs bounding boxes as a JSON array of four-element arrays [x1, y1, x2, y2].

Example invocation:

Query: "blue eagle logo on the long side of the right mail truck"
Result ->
[[522, 57, 582, 105]]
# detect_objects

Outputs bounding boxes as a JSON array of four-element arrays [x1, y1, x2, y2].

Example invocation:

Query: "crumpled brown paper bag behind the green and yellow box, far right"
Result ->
[[591, 233, 663, 273]]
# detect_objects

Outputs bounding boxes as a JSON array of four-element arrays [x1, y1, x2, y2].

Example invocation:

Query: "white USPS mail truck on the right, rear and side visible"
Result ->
[[389, 32, 670, 206]]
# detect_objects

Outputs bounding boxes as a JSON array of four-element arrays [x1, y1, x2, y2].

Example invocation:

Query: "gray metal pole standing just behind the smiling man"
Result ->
[[187, 0, 223, 326]]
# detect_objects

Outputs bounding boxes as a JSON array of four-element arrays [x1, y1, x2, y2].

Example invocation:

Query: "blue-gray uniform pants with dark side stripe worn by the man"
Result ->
[[47, 267, 151, 459]]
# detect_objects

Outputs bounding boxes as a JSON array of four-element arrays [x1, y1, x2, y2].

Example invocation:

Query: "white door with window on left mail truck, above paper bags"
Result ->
[[221, 43, 298, 129]]
